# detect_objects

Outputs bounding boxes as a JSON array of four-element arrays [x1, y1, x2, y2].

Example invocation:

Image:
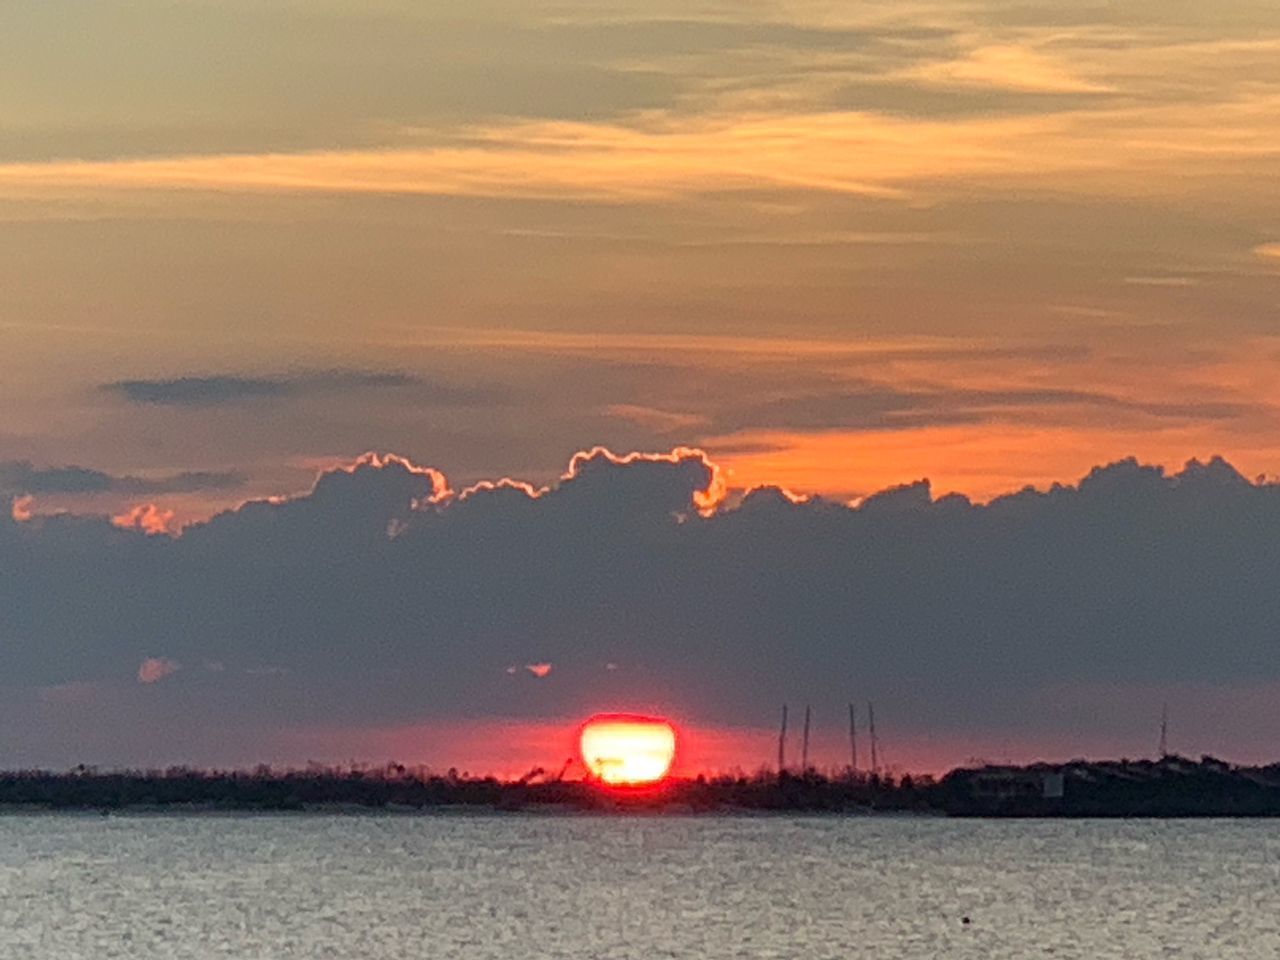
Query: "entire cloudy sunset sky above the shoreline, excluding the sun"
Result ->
[[0, 0, 1280, 771]]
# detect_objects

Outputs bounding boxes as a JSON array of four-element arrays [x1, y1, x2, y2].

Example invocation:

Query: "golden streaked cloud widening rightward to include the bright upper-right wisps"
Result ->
[[0, 43, 1280, 216]]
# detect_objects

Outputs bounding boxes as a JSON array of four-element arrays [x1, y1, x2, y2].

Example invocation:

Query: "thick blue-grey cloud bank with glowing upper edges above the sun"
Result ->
[[0, 452, 1280, 762]]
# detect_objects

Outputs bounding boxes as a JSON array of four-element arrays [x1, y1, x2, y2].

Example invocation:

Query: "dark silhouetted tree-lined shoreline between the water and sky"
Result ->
[[0, 756, 1280, 818]]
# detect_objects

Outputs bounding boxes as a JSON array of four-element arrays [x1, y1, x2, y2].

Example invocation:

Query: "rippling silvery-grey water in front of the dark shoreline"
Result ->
[[0, 815, 1280, 960]]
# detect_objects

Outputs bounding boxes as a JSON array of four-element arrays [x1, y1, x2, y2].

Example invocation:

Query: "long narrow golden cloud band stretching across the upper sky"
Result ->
[[0, 90, 1280, 204]]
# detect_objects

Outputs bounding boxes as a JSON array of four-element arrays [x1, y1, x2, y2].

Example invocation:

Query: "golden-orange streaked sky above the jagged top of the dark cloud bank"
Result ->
[[0, 0, 1280, 767]]
